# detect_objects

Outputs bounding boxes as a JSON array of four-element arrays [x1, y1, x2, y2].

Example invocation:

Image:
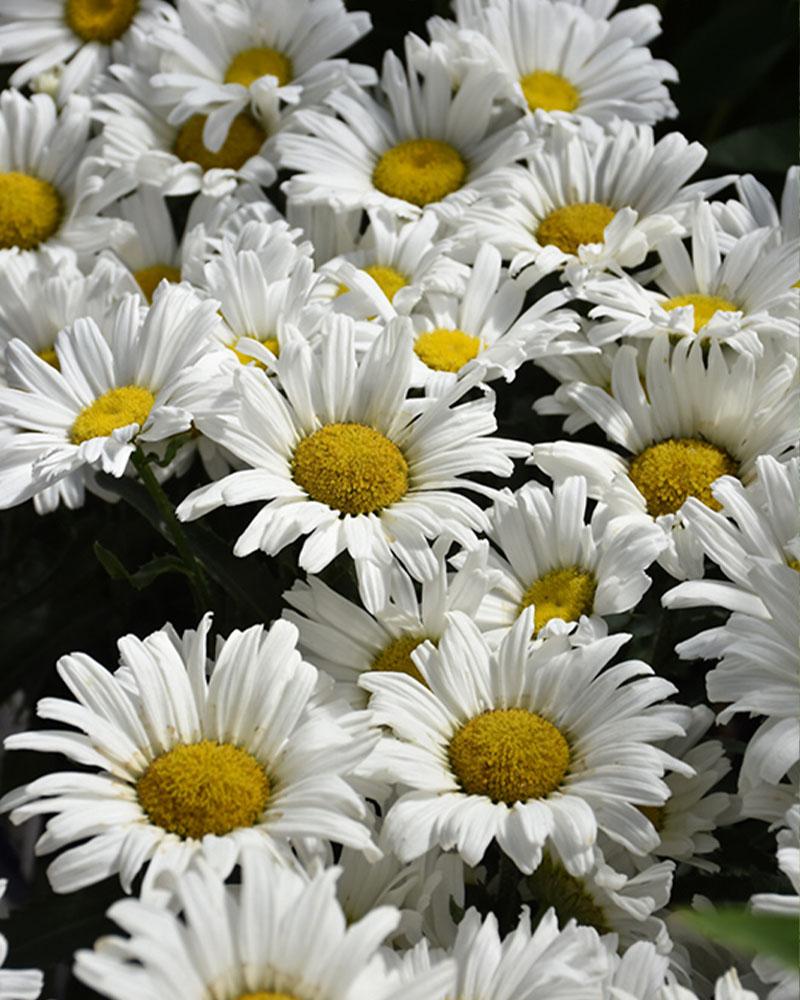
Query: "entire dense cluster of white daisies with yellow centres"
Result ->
[[0, 0, 800, 1000]]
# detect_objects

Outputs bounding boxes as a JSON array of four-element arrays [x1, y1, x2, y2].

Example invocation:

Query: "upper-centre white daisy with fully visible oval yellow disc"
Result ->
[[276, 42, 533, 218]]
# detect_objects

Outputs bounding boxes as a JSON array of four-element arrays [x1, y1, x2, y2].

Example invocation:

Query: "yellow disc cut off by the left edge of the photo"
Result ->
[[0, 170, 64, 250]]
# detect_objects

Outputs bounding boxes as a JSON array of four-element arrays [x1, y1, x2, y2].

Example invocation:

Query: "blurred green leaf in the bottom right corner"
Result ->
[[678, 906, 798, 969]]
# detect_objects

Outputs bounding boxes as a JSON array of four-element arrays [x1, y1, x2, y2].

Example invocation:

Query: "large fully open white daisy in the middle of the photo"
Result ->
[[178, 316, 530, 611]]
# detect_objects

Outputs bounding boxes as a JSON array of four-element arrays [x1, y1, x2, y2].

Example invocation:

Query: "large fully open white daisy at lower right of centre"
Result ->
[[360, 609, 691, 874]]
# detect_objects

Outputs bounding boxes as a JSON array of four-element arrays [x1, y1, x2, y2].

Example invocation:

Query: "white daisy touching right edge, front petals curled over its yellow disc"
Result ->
[[577, 201, 800, 356]]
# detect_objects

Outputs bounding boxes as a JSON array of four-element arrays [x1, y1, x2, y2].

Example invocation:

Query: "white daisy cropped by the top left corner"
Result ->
[[0, 0, 176, 104]]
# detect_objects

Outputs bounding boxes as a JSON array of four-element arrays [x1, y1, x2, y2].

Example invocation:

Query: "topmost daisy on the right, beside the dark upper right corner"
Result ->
[[440, 0, 677, 125]]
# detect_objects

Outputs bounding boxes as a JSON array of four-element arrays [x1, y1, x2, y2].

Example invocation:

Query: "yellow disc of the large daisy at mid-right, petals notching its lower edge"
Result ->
[[628, 438, 739, 517]]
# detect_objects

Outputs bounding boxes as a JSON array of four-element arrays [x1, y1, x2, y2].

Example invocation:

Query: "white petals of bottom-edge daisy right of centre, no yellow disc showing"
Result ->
[[390, 907, 609, 1000]]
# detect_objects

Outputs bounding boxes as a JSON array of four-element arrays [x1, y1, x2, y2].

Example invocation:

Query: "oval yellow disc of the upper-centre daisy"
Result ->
[[372, 139, 467, 205]]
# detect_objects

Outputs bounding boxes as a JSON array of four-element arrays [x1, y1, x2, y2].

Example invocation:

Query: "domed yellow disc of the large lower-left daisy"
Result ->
[[136, 740, 270, 840]]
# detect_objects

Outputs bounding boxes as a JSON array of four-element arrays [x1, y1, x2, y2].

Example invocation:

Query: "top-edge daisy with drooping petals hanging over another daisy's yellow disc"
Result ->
[[152, 0, 376, 152]]
